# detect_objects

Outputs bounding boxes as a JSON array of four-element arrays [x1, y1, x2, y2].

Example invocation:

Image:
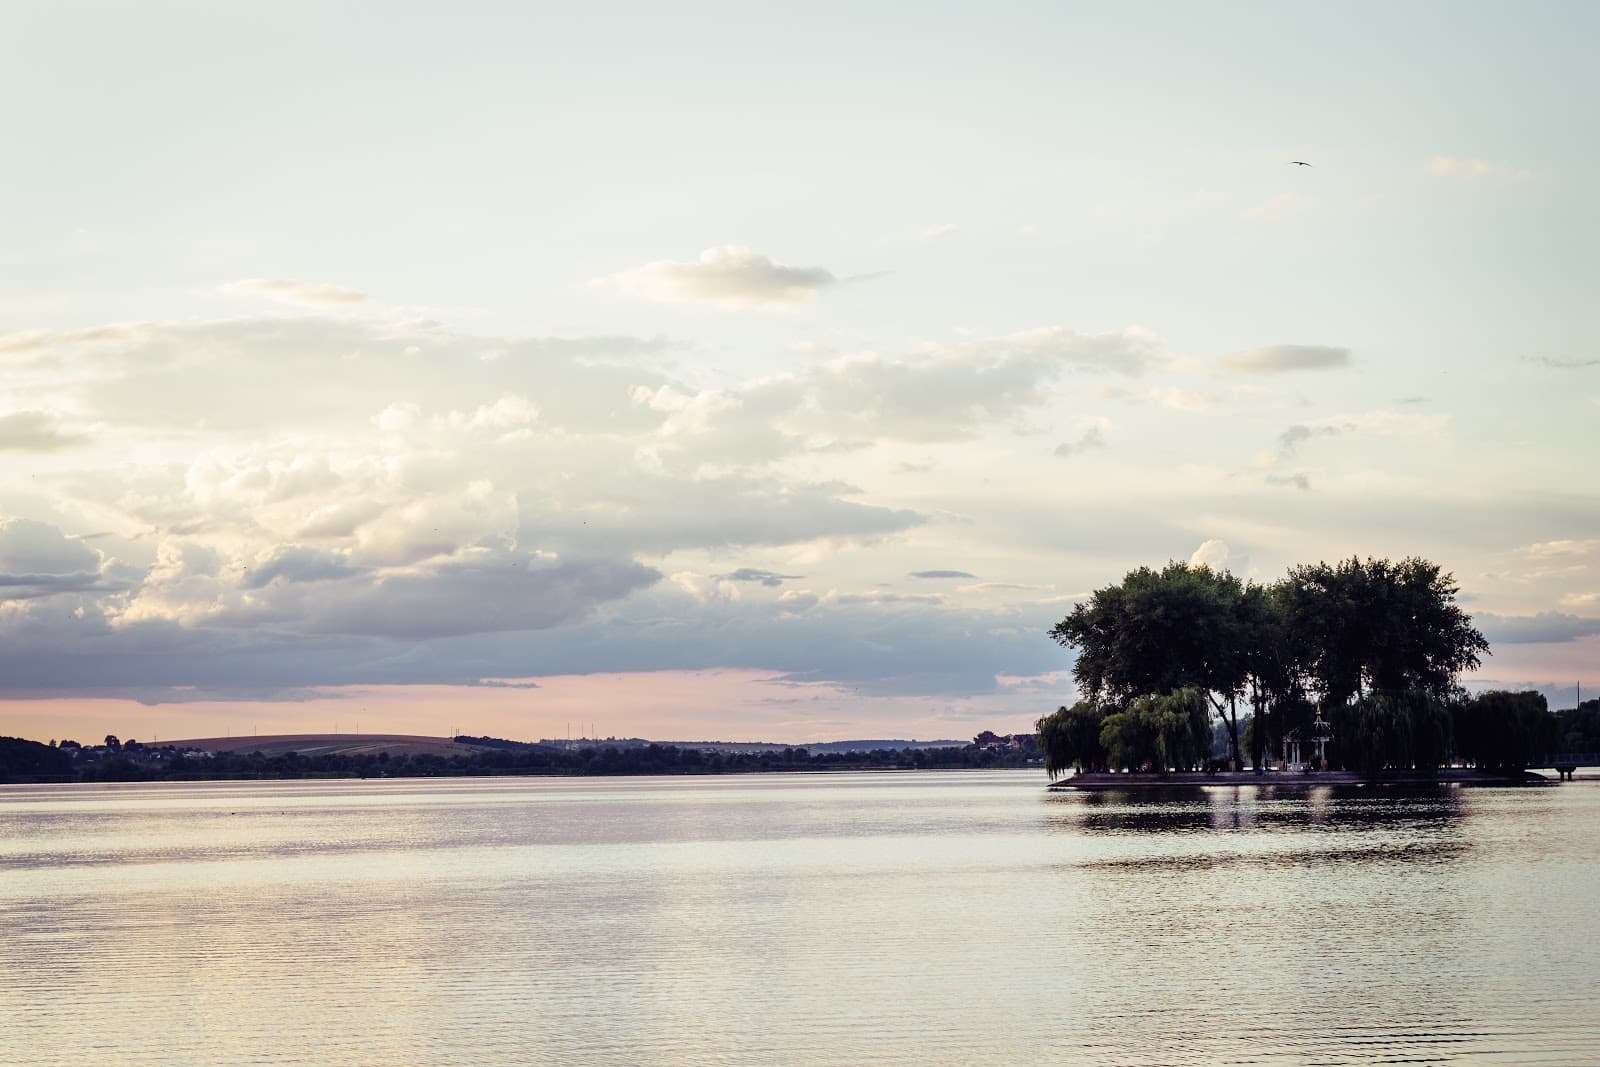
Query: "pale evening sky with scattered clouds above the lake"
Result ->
[[0, 0, 1600, 742]]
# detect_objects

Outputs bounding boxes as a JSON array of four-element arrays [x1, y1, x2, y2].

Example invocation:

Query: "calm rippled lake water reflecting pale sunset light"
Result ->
[[0, 771, 1600, 1067]]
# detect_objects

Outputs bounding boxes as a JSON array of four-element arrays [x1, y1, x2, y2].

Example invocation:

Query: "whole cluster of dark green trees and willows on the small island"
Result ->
[[1037, 558, 1582, 777]]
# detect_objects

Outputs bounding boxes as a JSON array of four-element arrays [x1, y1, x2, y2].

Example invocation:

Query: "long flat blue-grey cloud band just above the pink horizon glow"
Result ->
[[0, 574, 1070, 699]]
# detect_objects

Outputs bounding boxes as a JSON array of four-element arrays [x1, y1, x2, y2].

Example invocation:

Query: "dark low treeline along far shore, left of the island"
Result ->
[[0, 731, 1038, 782]]
